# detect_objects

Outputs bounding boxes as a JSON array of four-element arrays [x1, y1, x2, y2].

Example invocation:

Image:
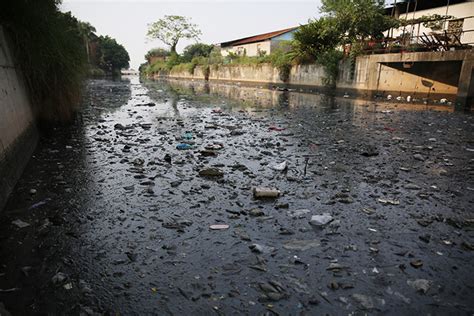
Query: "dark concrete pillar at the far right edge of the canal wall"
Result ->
[[455, 59, 474, 110]]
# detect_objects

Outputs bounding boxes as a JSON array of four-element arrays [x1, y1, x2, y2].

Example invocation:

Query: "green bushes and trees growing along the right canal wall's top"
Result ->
[[140, 0, 398, 87]]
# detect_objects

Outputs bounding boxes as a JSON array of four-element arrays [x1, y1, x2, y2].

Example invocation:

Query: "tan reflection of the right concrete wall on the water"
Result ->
[[146, 79, 453, 112]]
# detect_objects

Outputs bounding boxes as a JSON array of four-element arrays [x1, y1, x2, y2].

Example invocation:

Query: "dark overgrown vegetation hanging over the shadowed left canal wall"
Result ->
[[0, 0, 128, 122]]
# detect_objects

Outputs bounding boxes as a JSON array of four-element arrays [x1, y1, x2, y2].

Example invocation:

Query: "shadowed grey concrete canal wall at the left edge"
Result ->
[[0, 26, 38, 211]]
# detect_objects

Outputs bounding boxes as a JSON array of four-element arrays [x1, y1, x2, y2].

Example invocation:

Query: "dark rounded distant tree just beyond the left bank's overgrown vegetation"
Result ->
[[99, 36, 130, 73]]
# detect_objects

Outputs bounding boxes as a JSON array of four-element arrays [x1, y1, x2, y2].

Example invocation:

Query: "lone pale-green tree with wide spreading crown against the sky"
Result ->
[[147, 15, 202, 54]]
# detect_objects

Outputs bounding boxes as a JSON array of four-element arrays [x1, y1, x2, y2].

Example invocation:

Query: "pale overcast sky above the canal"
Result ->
[[61, 0, 320, 69]]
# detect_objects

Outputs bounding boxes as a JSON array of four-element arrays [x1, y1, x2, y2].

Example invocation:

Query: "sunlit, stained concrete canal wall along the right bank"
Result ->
[[160, 50, 474, 108]]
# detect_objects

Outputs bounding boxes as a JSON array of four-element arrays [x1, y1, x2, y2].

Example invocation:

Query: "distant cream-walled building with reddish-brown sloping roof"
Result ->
[[220, 27, 298, 56]]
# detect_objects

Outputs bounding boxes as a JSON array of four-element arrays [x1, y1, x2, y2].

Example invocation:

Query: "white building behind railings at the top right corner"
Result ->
[[386, 0, 474, 49]]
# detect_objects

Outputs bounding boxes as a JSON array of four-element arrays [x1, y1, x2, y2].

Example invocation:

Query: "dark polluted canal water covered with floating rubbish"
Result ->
[[0, 78, 474, 315]]
